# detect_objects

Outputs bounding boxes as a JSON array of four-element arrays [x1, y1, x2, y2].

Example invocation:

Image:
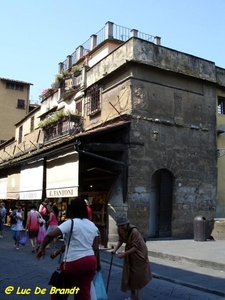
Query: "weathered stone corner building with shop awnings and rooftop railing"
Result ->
[[0, 22, 225, 246]]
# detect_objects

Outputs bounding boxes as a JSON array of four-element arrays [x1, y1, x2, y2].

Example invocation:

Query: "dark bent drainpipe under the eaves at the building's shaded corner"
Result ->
[[74, 141, 127, 203]]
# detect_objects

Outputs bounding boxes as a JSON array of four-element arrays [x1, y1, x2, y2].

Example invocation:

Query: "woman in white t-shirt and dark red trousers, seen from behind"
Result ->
[[37, 197, 101, 300]]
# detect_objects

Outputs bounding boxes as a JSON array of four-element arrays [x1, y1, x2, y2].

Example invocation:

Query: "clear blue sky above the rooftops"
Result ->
[[0, 0, 225, 103]]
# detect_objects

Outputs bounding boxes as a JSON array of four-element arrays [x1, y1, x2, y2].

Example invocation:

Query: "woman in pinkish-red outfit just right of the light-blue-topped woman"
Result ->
[[25, 203, 39, 252]]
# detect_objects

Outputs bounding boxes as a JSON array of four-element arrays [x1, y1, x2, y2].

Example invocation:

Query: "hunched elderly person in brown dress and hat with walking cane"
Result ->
[[111, 213, 152, 300]]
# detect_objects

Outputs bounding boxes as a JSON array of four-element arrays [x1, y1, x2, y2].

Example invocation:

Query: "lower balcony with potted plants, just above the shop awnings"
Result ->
[[43, 115, 83, 143]]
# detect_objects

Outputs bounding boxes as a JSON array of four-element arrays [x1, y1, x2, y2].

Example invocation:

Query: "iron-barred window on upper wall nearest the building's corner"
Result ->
[[87, 84, 101, 115]]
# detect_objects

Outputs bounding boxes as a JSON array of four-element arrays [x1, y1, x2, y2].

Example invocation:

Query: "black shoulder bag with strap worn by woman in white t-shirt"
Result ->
[[48, 219, 73, 288]]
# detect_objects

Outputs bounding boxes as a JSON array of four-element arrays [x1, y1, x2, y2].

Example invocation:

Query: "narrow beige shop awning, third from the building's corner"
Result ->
[[6, 168, 20, 200]]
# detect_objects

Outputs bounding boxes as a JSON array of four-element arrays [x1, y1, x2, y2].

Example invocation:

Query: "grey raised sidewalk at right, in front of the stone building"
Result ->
[[104, 238, 225, 297]]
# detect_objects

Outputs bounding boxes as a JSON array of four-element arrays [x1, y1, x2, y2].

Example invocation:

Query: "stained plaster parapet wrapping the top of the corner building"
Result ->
[[87, 38, 216, 86]]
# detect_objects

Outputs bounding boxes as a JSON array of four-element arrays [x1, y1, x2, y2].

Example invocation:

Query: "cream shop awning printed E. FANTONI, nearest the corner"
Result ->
[[46, 150, 79, 198]]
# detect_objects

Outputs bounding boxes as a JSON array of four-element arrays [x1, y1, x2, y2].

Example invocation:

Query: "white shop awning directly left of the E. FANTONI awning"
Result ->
[[20, 159, 44, 200]]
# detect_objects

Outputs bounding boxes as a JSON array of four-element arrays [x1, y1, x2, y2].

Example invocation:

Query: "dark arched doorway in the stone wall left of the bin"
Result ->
[[149, 169, 174, 237]]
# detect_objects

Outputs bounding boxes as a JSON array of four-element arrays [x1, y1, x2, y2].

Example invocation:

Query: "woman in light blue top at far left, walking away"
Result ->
[[10, 206, 24, 250]]
